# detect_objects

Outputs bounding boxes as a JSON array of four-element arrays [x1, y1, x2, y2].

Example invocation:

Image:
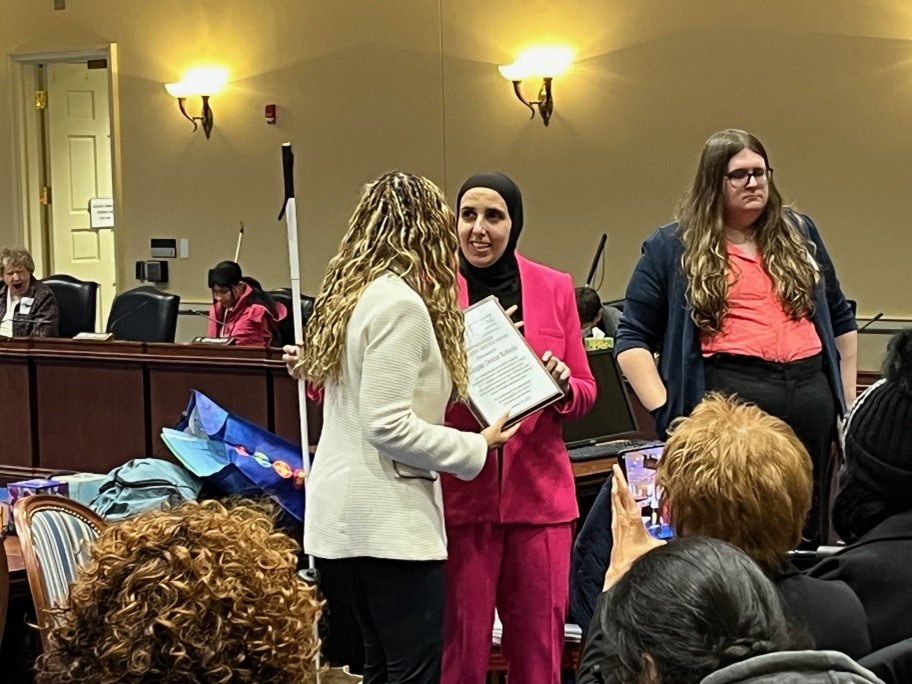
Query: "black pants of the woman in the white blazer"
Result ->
[[318, 557, 445, 684]]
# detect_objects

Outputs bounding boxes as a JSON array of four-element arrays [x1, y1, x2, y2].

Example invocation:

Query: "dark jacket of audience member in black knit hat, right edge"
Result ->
[[808, 510, 912, 649]]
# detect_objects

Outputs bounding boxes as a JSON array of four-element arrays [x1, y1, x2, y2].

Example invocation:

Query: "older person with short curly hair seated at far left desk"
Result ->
[[0, 248, 58, 337]]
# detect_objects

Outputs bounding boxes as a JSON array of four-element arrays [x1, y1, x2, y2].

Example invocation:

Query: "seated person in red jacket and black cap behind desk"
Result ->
[[206, 261, 286, 347]]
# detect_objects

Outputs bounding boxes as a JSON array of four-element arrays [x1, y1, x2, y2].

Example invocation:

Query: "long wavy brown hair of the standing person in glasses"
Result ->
[[676, 129, 819, 335]]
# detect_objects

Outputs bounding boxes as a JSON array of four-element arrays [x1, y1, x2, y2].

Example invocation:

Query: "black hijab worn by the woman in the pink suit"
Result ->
[[456, 172, 523, 321]]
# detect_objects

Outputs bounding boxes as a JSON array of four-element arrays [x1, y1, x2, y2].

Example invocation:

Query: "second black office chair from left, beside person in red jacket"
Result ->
[[107, 285, 180, 342]]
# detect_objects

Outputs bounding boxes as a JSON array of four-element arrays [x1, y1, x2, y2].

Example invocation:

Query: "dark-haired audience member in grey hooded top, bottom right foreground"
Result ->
[[577, 536, 882, 684]]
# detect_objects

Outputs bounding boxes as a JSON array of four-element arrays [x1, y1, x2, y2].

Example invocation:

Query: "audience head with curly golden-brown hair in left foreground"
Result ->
[[38, 501, 320, 684]]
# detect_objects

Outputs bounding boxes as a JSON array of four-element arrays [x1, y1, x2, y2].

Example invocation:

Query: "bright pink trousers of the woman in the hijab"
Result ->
[[441, 522, 573, 684]]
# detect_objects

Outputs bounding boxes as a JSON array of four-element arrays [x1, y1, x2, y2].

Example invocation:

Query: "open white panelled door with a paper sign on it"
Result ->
[[47, 62, 117, 330]]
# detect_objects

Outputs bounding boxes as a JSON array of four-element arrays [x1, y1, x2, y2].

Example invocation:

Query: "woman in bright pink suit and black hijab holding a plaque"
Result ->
[[442, 173, 596, 684]]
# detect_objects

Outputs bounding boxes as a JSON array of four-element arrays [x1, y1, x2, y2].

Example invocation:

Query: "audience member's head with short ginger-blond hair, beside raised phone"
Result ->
[[656, 394, 812, 571]]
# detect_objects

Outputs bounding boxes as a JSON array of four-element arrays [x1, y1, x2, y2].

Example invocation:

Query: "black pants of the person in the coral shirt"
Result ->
[[705, 354, 836, 548]]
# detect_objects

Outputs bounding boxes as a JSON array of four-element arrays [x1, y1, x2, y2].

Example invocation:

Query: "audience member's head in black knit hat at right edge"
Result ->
[[833, 329, 912, 542]]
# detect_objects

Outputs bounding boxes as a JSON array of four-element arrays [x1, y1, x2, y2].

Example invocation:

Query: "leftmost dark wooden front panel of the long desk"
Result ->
[[0, 340, 37, 468]]
